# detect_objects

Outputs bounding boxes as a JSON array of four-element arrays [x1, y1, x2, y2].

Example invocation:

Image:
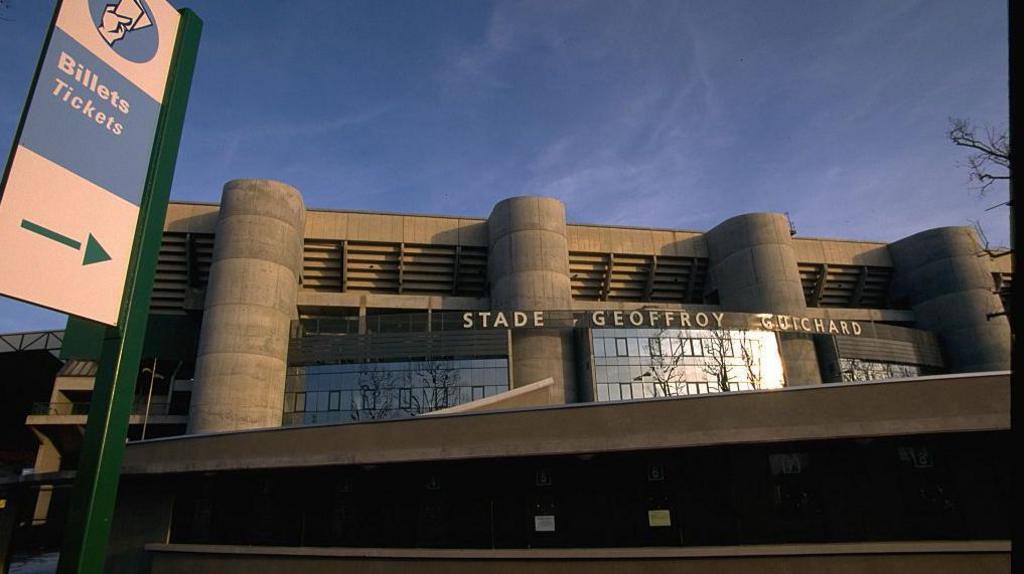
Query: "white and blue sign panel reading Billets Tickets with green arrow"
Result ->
[[0, 0, 180, 325]]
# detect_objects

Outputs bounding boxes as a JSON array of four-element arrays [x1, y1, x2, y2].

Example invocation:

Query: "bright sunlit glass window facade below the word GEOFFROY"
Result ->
[[590, 328, 784, 401]]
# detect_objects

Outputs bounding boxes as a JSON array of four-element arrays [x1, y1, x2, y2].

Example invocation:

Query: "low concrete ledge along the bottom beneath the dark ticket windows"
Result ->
[[145, 540, 1010, 574]]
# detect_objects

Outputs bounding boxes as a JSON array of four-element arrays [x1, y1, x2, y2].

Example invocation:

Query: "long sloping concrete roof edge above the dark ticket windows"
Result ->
[[123, 371, 1010, 475]]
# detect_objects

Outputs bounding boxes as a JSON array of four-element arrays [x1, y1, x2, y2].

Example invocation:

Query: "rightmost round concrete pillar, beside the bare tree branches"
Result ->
[[889, 227, 1010, 372]]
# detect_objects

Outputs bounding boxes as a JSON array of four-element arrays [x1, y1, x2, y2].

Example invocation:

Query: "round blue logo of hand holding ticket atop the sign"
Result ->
[[89, 0, 160, 63]]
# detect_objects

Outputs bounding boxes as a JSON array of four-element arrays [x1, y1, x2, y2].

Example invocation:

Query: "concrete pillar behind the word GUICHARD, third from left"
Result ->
[[705, 213, 821, 386]]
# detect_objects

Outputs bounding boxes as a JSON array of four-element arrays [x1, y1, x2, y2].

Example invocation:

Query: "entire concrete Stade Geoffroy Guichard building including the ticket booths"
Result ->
[[0, 180, 1013, 573]]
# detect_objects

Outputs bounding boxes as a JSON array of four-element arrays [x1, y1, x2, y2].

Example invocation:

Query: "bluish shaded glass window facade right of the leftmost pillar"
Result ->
[[284, 358, 509, 426]]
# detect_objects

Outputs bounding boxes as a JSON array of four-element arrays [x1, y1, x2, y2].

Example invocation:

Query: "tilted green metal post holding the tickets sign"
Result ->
[[57, 9, 203, 574]]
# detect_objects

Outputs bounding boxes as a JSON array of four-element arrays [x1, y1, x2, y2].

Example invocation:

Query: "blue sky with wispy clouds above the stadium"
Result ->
[[0, 0, 1009, 333]]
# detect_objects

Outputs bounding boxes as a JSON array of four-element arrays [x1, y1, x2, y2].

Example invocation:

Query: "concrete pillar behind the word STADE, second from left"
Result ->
[[487, 196, 577, 402]]
